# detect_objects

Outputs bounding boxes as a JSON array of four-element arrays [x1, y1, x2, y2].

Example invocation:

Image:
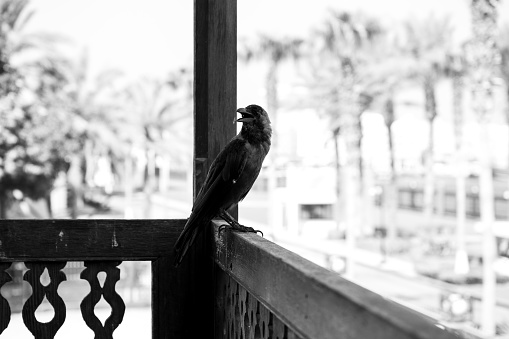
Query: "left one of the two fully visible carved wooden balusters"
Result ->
[[22, 261, 66, 339]]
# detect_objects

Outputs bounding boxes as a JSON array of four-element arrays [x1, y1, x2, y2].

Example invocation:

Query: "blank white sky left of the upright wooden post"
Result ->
[[26, 0, 193, 77]]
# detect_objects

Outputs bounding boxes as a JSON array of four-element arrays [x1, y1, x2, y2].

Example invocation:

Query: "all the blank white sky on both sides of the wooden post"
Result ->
[[24, 0, 509, 76]]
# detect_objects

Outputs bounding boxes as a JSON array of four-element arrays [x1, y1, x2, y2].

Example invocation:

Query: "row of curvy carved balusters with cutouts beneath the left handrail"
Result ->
[[0, 261, 125, 339]]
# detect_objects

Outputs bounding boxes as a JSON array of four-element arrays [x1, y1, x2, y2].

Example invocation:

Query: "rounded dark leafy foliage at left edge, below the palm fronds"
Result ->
[[0, 98, 77, 199]]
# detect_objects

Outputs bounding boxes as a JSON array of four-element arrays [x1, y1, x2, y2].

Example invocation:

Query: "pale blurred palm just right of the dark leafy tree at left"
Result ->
[[52, 51, 128, 218]]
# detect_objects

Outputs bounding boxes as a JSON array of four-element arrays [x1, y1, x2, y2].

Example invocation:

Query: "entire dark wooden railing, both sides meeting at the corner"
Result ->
[[0, 220, 466, 339]]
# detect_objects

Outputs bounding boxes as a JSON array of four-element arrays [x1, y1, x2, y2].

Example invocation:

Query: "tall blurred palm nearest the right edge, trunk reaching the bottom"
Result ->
[[467, 0, 500, 336]]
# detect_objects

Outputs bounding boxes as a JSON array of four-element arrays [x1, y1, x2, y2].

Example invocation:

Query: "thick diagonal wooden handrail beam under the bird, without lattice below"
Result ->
[[213, 223, 460, 339]]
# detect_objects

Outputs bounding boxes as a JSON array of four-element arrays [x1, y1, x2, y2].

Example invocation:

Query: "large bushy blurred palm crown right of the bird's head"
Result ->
[[308, 12, 384, 131]]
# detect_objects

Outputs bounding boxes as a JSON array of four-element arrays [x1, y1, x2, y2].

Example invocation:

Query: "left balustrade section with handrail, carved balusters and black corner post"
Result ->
[[0, 220, 213, 339]]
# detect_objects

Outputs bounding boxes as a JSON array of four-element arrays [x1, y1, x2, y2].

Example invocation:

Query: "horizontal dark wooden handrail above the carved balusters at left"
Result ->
[[0, 219, 185, 262]]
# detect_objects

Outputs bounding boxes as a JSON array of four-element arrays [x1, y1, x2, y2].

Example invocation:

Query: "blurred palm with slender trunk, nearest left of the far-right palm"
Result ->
[[401, 16, 452, 231]]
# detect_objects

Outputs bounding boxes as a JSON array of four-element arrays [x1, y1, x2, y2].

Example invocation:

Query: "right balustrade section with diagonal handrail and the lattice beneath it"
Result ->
[[210, 224, 461, 339]]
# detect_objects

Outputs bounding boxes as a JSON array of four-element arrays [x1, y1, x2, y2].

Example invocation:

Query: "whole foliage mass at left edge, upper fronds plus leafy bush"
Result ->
[[0, 0, 77, 202]]
